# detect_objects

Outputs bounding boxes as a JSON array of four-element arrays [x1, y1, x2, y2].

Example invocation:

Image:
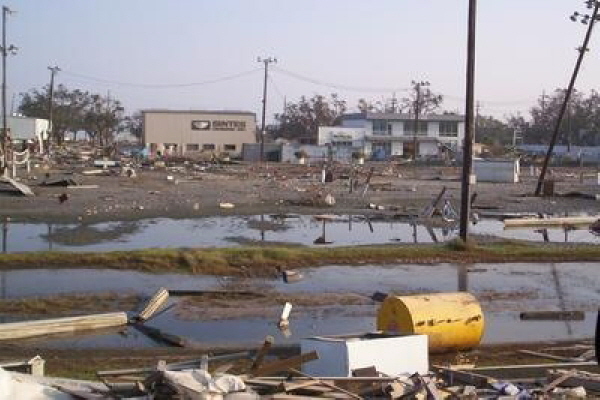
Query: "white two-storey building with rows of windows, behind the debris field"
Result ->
[[318, 113, 465, 159]]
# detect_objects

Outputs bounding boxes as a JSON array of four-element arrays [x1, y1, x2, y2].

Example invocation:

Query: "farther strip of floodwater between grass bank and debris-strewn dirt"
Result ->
[[0, 215, 600, 253]]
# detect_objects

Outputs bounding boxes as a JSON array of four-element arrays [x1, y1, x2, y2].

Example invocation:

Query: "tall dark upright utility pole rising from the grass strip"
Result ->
[[460, 0, 477, 242]]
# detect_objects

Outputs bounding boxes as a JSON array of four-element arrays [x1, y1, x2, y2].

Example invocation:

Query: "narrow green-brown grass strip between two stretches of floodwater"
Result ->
[[0, 240, 600, 277]]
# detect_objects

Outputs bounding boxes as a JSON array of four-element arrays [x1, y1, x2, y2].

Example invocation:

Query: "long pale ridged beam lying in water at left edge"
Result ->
[[0, 312, 127, 340]]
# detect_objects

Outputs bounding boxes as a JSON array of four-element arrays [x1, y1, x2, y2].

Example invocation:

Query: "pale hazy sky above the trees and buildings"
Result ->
[[4, 0, 600, 119]]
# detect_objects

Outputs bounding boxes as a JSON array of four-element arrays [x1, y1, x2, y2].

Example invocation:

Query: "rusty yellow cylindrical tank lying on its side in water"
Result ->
[[377, 293, 484, 353]]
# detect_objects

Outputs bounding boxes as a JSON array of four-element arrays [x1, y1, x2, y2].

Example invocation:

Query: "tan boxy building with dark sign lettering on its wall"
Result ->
[[142, 110, 256, 156]]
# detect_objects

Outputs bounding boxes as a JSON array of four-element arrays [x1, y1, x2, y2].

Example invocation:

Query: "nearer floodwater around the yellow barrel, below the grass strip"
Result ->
[[0, 263, 600, 347]]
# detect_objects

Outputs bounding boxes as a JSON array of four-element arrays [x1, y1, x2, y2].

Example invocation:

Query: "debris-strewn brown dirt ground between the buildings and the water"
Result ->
[[0, 163, 600, 222]]
